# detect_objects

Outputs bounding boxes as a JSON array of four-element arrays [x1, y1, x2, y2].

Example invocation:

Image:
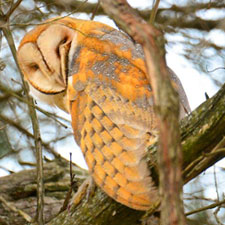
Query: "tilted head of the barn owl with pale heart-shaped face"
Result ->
[[17, 18, 80, 111]]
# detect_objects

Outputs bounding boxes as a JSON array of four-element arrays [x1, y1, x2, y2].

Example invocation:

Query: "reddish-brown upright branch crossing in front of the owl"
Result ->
[[99, 0, 186, 225]]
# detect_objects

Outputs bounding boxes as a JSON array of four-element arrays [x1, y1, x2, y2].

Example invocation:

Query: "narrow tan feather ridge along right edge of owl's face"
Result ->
[[59, 41, 71, 86]]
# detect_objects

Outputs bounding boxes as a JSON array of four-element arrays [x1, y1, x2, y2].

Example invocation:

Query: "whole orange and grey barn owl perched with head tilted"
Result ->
[[17, 17, 189, 210]]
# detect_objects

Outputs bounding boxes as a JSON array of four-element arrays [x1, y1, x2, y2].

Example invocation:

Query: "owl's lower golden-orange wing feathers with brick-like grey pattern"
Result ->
[[71, 78, 157, 210]]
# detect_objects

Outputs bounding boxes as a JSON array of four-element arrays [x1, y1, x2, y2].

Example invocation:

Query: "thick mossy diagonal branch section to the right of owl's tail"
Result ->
[[148, 82, 225, 183]]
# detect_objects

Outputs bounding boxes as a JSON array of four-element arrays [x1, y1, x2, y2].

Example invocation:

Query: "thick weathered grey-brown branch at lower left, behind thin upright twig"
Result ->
[[0, 159, 86, 225]]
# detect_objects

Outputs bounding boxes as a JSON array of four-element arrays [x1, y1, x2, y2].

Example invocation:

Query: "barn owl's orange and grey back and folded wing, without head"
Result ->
[[67, 24, 190, 210]]
